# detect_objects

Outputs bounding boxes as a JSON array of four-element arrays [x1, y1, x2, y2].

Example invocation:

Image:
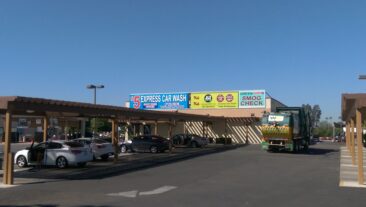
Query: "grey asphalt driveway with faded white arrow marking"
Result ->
[[0, 143, 366, 207]]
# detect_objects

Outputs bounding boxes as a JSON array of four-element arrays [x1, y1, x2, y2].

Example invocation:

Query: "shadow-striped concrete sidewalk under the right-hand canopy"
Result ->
[[339, 146, 366, 188]]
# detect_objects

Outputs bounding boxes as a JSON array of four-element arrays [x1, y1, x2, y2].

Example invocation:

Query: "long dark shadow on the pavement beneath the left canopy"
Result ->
[[6, 145, 245, 184]]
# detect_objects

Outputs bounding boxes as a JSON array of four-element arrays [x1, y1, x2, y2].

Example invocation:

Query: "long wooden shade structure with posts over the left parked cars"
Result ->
[[0, 96, 257, 184]]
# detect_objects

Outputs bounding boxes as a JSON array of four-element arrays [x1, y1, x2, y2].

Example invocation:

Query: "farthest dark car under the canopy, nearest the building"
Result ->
[[172, 134, 208, 147]]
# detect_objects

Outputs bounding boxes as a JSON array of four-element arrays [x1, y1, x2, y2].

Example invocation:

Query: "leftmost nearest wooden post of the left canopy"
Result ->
[[3, 111, 14, 185]]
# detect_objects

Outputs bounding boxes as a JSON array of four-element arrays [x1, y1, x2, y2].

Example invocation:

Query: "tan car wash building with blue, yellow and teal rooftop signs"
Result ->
[[126, 90, 285, 144]]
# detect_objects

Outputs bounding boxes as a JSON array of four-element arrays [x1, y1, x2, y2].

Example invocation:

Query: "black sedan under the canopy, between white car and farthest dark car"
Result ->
[[120, 135, 169, 153]]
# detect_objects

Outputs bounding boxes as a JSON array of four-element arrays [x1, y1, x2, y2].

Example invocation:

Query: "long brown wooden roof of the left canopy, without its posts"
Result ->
[[0, 96, 225, 121]]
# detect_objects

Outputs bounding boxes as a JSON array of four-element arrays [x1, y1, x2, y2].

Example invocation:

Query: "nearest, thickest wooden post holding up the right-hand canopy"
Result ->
[[356, 109, 364, 185]]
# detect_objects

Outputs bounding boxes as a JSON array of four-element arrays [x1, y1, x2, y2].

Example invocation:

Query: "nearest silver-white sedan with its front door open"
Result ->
[[14, 141, 93, 168]]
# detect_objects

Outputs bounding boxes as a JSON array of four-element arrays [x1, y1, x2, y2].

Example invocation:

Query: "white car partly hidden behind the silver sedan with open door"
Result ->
[[73, 138, 114, 160]]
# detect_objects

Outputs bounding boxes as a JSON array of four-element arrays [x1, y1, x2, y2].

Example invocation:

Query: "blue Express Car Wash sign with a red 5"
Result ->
[[130, 93, 189, 110]]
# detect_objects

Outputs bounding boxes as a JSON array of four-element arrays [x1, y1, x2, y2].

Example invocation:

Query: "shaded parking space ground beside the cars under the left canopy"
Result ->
[[0, 144, 243, 185]]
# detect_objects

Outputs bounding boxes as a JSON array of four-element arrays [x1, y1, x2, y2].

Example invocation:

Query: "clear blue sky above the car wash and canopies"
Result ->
[[0, 0, 366, 120]]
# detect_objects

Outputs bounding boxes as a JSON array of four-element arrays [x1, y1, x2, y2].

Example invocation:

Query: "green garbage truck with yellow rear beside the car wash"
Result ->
[[261, 107, 311, 152]]
